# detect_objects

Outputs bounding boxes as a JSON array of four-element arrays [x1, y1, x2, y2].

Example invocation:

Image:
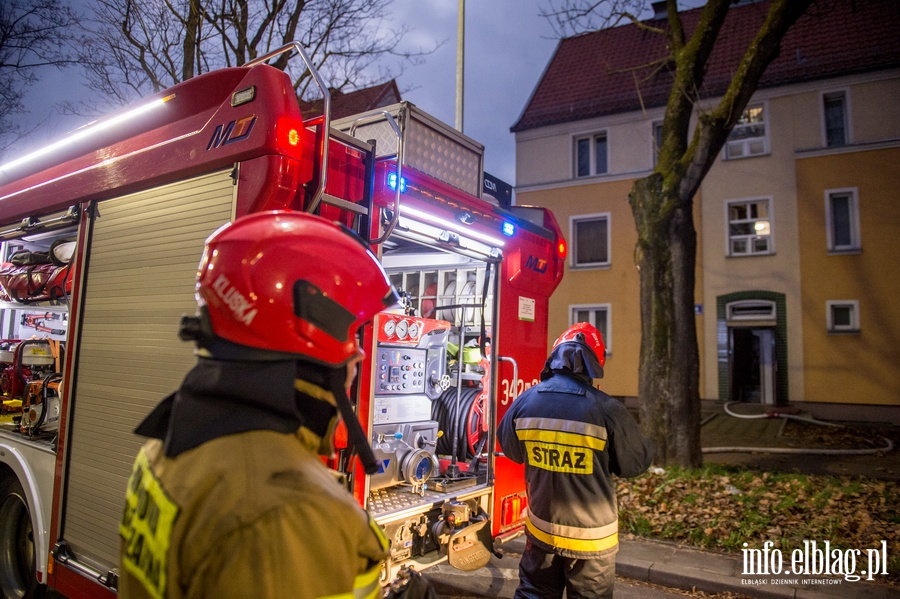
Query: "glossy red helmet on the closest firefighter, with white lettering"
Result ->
[[197, 210, 397, 366]]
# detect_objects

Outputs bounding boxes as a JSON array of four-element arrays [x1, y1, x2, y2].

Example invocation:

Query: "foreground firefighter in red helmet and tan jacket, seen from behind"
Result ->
[[118, 211, 397, 599]]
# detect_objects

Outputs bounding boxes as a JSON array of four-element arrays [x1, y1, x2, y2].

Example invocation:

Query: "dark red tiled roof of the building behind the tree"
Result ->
[[510, 0, 900, 132]]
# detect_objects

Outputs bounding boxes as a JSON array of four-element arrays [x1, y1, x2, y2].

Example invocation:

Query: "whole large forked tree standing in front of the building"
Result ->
[[543, 0, 812, 466]]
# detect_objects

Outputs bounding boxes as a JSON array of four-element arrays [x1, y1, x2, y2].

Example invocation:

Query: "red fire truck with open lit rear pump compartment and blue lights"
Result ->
[[0, 43, 565, 599]]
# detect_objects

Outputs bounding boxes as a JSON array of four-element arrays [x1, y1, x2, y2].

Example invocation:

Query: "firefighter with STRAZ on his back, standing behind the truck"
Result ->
[[497, 322, 654, 599]]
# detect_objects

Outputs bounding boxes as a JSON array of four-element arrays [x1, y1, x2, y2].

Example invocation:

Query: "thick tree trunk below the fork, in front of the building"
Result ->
[[629, 173, 703, 467]]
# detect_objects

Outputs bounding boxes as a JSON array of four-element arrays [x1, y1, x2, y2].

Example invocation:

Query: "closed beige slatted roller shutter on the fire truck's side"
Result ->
[[62, 171, 237, 573]]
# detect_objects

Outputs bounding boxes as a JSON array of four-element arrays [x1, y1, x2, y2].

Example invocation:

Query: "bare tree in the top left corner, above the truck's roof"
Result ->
[[0, 0, 76, 152]]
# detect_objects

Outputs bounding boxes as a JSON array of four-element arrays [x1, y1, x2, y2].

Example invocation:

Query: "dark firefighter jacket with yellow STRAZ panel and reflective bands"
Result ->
[[497, 371, 653, 559]]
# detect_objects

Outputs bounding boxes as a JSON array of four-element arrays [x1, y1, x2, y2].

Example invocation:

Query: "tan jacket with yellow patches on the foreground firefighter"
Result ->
[[119, 364, 387, 599]]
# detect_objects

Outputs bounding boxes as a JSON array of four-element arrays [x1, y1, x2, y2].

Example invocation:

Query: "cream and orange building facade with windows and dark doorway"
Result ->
[[513, 4, 900, 406]]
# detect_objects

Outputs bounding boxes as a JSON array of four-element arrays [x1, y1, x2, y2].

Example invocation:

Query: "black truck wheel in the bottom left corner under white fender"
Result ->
[[0, 476, 44, 599]]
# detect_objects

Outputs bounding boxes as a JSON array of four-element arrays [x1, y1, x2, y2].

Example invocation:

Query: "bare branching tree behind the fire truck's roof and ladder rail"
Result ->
[[69, 0, 433, 114]]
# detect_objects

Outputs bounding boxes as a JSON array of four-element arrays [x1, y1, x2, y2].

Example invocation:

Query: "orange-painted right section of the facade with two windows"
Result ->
[[797, 147, 900, 405]]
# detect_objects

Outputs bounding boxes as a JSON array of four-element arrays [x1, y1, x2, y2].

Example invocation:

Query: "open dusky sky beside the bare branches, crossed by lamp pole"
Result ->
[[12, 0, 557, 184]]
